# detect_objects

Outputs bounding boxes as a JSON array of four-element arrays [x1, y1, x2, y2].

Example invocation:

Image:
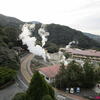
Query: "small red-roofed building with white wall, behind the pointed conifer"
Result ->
[[38, 65, 60, 83]]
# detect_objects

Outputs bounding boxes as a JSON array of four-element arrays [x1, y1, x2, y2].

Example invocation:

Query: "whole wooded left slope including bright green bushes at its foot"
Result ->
[[0, 16, 21, 86]]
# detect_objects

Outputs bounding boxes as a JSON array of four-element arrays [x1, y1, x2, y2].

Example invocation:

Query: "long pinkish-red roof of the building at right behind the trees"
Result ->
[[66, 48, 100, 57]]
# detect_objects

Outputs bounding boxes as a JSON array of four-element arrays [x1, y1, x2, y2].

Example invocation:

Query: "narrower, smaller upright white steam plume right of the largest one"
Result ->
[[38, 24, 49, 47]]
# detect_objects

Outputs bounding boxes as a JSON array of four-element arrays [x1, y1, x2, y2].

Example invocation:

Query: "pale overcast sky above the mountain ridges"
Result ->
[[0, 0, 100, 35]]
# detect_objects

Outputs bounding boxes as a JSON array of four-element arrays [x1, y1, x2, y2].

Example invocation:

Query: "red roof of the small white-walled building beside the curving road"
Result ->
[[38, 65, 60, 78]]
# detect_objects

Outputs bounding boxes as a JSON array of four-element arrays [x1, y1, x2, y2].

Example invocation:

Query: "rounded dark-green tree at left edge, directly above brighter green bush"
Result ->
[[0, 47, 19, 69]]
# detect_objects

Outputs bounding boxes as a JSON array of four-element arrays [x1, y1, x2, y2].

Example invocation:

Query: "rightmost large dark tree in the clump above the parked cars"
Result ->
[[82, 61, 99, 88]]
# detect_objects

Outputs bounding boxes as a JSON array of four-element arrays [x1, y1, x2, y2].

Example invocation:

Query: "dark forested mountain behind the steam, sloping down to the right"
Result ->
[[33, 24, 100, 49]]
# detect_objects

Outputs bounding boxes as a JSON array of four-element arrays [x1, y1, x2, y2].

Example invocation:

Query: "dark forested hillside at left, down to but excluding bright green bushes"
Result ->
[[0, 14, 23, 69]]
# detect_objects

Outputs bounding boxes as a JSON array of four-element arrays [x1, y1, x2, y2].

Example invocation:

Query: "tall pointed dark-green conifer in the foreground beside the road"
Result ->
[[27, 72, 54, 100]]
